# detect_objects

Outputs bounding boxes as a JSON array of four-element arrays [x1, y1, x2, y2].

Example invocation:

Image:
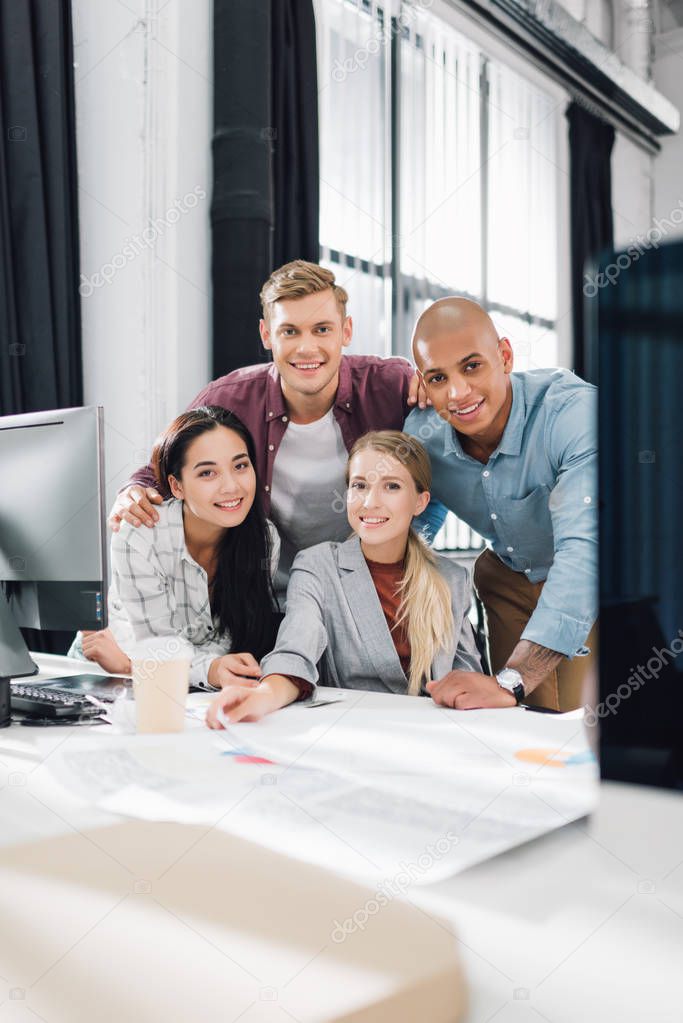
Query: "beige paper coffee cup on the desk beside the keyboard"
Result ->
[[131, 641, 191, 735]]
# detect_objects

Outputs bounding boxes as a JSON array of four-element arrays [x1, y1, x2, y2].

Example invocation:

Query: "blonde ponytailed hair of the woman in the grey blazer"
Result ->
[[347, 430, 453, 696]]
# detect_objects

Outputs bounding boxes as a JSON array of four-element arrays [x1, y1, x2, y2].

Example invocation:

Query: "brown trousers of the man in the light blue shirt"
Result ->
[[474, 550, 597, 711]]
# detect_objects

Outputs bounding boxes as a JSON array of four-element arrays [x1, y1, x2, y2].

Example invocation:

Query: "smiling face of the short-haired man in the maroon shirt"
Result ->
[[261, 287, 353, 396]]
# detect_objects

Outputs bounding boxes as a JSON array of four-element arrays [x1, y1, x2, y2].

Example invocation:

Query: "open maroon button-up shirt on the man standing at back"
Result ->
[[129, 355, 415, 515]]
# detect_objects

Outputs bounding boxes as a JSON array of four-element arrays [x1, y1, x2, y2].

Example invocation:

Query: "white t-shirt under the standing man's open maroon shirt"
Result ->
[[271, 408, 351, 604]]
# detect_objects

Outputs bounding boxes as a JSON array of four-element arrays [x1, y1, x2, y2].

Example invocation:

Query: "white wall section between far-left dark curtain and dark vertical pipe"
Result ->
[[74, 0, 213, 511]]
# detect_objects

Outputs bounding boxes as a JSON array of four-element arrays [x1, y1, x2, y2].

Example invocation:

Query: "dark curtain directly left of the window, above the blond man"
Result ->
[[272, 0, 319, 267]]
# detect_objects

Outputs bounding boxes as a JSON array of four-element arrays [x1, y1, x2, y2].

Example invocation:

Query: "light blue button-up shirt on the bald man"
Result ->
[[404, 369, 597, 657]]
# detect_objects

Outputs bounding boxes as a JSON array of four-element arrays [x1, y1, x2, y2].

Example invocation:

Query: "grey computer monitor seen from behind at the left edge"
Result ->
[[0, 406, 106, 718]]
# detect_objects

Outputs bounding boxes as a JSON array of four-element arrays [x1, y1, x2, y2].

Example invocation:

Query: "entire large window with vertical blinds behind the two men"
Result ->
[[316, 0, 563, 548]]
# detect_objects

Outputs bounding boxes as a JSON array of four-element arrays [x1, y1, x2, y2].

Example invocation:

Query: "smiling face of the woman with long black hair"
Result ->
[[169, 426, 256, 529]]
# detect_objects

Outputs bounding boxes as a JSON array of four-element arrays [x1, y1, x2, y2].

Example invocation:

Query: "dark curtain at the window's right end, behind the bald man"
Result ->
[[566, 102, 614, 377]]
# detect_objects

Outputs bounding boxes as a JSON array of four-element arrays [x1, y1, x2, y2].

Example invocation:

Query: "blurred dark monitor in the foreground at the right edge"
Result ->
[[587, 242, 683, 788]]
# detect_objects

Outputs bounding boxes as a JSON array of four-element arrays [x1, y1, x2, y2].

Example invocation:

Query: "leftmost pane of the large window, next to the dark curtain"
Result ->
[[316, 0, 392, 355]]
